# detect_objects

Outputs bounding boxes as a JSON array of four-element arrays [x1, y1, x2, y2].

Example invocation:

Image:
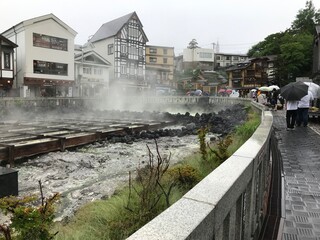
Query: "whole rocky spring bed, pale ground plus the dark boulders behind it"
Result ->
[[0, 105, 246, 220]]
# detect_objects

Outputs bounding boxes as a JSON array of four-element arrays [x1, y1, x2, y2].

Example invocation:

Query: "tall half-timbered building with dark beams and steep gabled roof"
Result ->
[[84, 12, 149, 93]]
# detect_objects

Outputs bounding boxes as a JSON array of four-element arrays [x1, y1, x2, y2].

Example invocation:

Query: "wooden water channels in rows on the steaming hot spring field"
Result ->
[[0, 118, 173, 166]]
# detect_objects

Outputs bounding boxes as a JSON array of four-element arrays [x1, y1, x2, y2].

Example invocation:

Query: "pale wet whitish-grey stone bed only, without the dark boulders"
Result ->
[[16, 135, 201, 220]]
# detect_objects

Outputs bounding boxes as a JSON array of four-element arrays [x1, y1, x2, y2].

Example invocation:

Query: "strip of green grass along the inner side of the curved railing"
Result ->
[[53, 108, 260, 240]]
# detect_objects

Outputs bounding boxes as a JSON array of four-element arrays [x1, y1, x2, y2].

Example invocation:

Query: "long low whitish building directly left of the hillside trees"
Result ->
[[214, 53, 248, 70]]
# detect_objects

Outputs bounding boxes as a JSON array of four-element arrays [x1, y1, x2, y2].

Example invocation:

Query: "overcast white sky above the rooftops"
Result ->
[[0, 0, 320, 55]]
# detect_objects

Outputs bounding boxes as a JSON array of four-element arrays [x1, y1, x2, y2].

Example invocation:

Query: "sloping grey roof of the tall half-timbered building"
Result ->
[[90, 12, 135, 42]]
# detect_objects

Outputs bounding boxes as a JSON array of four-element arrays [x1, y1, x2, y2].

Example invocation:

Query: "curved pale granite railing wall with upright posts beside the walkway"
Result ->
[[128, 102, 273, 240]]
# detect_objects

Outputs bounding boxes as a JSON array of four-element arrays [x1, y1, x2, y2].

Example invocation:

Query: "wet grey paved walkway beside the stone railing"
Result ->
[[273, 110, 320, 240]]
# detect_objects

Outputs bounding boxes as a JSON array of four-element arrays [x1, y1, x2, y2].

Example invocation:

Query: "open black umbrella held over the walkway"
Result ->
[[280, 82, 308, 101]]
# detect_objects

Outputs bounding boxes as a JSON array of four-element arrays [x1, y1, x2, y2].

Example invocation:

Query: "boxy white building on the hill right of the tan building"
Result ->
[[183, 47, 214, 71]]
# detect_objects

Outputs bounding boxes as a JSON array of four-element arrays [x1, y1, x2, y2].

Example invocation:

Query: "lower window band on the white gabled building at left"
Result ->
[[33, 60, 68, 76]]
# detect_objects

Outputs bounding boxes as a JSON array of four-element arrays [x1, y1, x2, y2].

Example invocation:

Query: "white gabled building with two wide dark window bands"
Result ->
[[2, 14, 77, 97]]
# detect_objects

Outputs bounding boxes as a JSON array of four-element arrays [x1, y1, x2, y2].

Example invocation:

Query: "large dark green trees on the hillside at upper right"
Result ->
[[248, 1, 320, 86]]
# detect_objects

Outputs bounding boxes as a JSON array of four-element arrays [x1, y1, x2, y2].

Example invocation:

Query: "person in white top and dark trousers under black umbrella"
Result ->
[[280, 82, 308, 130]]
